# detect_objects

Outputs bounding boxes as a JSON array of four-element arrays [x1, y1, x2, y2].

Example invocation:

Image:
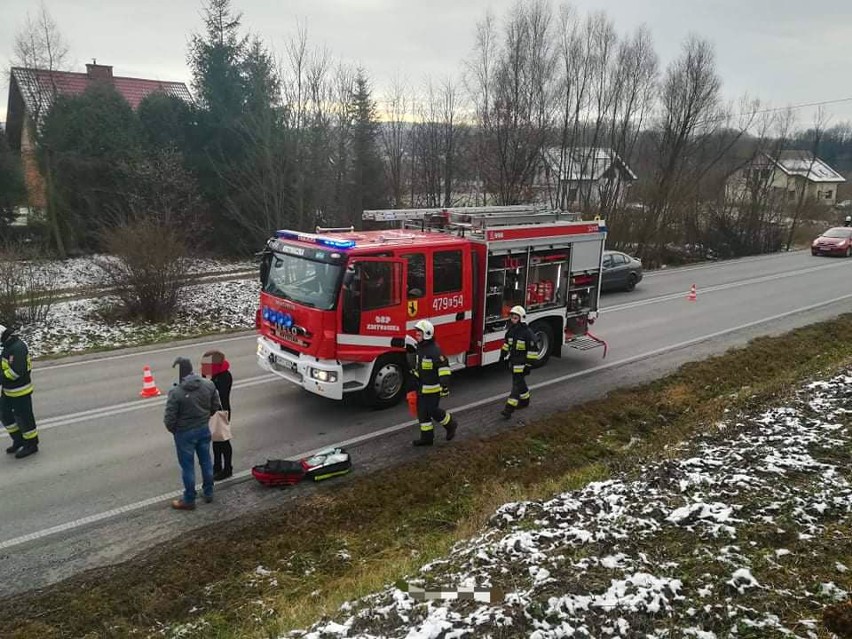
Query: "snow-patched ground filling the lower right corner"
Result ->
[[292, 373, 852, 639]]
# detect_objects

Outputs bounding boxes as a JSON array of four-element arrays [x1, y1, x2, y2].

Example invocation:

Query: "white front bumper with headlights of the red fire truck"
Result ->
[[257, 337, 343, 399]]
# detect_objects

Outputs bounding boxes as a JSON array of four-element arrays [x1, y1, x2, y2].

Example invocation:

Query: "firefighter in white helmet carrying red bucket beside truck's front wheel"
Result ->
[[413, 320, 458, 446]]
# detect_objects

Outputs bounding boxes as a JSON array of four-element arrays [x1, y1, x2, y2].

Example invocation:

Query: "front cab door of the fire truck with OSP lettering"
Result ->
[[342, 257, 407, 346]]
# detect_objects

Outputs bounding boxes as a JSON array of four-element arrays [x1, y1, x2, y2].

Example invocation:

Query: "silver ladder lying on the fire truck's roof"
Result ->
[[362, 205, 580, 233]]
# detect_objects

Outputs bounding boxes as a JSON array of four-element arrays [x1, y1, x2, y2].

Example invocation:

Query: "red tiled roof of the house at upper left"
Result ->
[[12, 65, 192, 120]]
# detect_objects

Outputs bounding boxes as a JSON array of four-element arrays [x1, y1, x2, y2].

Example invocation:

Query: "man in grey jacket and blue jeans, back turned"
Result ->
[[163, 357, 222, 510]]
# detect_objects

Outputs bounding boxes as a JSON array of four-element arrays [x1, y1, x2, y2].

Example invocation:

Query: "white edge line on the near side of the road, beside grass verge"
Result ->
[[0, 293, 852, 550]]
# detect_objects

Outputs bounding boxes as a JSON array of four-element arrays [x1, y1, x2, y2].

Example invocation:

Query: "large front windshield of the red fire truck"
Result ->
[[263, 251, 343, 311]]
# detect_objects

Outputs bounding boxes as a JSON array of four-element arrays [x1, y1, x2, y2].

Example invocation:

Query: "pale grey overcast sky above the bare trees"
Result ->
[[0, 0, 852, 127]]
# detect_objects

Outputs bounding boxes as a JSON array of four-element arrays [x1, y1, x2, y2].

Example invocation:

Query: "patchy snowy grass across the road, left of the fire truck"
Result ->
[[27, 278, 260, 357]]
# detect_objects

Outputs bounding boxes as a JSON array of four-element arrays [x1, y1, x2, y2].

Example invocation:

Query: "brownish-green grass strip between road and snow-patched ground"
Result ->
[[0, 315, 852, 638]]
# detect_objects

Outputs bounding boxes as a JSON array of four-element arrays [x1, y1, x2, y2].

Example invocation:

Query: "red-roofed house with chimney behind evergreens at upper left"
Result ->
[[6, 61, 192, 208]]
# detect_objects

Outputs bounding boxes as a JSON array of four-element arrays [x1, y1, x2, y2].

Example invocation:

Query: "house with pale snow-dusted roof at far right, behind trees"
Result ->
[[725, 150, 846, 206]]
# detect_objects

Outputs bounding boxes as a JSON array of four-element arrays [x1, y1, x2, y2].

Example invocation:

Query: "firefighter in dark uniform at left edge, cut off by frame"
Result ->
[[0, 326, 38, 459]]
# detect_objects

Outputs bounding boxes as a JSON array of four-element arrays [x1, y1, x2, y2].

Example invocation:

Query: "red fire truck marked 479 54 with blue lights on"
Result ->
[[256, 206, 607, 407]]
